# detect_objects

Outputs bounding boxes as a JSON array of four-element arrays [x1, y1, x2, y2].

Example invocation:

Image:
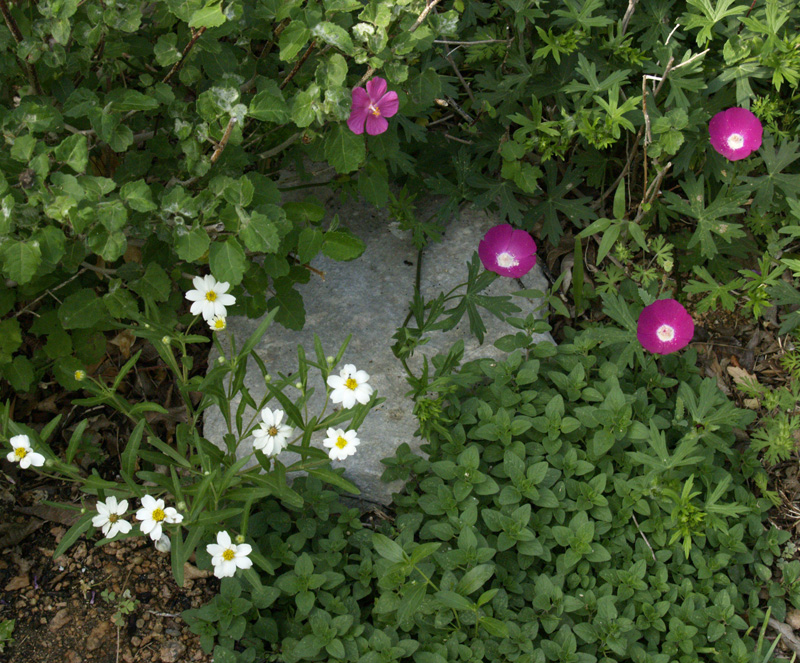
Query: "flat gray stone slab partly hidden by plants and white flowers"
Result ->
[[204, 201, 552, 504]]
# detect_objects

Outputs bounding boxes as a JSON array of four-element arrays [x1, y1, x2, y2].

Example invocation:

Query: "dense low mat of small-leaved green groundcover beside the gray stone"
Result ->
[[184, 324, 780, 663]]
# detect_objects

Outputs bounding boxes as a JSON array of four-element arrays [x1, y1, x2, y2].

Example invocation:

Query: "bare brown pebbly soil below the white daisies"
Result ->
[[0, 477, 219, 663]]
